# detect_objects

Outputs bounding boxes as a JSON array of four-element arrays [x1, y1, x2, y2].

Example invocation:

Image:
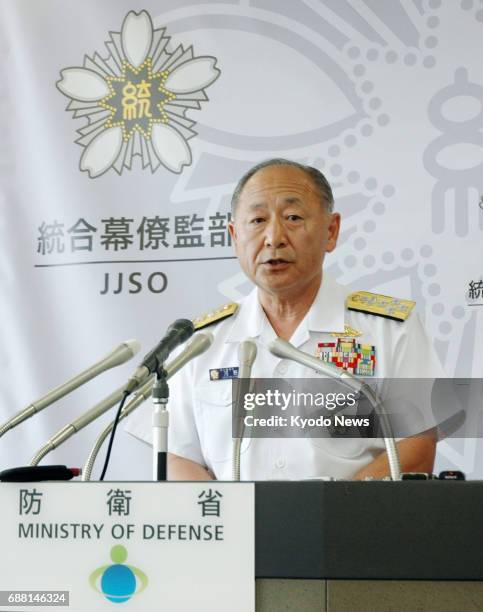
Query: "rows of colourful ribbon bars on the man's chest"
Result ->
[[315, 338, 376, 376]]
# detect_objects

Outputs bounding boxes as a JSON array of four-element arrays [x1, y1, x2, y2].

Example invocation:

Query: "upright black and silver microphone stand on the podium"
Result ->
[[152, 365, 169, 481]]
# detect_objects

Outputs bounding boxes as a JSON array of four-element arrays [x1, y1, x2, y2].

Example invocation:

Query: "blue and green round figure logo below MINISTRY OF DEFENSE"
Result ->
[[89, 544, 148, 603]]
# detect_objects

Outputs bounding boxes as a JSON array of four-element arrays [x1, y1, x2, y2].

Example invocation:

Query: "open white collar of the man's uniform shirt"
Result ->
[[225, 273, 348, 345]]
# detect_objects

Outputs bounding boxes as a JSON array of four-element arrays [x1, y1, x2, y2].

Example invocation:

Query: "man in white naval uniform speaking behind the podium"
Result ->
[[127, 160, 442, 480]]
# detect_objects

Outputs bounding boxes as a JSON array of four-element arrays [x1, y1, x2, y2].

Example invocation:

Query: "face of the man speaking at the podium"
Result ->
[[229, 166, 340, 296]]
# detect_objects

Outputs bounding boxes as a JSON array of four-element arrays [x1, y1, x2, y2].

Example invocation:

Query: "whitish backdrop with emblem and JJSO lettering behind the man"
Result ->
[[0, 0, 483, 479]]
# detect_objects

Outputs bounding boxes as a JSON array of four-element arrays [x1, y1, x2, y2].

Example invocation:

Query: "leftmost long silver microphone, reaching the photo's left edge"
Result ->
[[0, 340, 140, 438]]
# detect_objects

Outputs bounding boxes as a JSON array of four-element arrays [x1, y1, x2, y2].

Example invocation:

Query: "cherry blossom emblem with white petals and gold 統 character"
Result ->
[[56, 11, 220, 178]]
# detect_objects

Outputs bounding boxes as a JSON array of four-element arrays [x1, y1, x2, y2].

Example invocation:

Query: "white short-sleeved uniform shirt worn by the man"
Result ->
[[126, 275, 443, 480]]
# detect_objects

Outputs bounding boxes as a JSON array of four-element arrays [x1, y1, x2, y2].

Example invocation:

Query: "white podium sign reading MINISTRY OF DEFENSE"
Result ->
[[0, 482, 255, 612]]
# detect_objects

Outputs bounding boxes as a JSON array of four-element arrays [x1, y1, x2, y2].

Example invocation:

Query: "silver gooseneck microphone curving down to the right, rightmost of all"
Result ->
[[268, 338, 401, 480]]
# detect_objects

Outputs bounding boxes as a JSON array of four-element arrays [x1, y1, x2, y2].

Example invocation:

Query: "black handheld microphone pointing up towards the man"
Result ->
[[125, 319, 195, 394]]
